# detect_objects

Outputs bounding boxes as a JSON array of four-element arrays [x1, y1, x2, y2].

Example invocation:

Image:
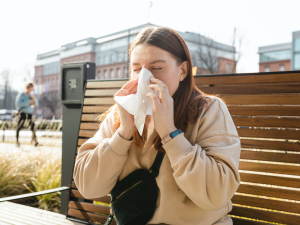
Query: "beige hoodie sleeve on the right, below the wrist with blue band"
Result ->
[[163, 97, 241, 210]]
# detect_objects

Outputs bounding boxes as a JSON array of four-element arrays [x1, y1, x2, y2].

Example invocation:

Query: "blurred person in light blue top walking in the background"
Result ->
[[15, 82, 39, 147]]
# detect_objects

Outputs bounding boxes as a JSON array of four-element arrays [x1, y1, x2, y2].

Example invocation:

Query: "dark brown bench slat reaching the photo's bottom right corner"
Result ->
[[229, 206, 300, 225]]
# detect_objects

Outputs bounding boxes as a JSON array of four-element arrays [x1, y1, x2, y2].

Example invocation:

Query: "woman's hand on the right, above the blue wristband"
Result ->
[[146, 77, 177, 138]]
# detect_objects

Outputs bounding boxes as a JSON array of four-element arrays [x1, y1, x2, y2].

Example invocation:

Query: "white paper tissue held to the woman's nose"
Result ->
[[114, 68, 157, 135]]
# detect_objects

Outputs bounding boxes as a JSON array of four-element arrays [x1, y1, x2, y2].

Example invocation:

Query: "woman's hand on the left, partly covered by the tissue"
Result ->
[[115, 78, 138, 140]]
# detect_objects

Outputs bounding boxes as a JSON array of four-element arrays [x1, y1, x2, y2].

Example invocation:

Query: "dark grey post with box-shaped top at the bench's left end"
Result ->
[[60, 62, 96, 215]]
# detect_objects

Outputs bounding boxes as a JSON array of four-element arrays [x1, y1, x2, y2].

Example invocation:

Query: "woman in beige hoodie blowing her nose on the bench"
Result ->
[[74, 27, 240, 225]]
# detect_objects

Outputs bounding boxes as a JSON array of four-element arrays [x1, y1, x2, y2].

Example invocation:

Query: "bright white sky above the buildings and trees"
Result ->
[[0, 0, 300, 88]]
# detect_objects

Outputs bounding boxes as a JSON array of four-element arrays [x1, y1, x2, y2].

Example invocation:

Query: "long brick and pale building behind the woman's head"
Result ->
[[34, 24, 235, 118]]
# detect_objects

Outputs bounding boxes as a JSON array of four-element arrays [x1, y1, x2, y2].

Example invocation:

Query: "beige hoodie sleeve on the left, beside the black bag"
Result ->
[[73, 110, 132, 198]]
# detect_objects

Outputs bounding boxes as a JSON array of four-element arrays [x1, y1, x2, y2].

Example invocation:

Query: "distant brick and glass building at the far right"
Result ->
[[258, 31, 300, 72]]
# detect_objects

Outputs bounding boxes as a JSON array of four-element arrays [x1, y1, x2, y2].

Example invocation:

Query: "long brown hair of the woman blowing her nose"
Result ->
[[100, 26, 209, 152]]
